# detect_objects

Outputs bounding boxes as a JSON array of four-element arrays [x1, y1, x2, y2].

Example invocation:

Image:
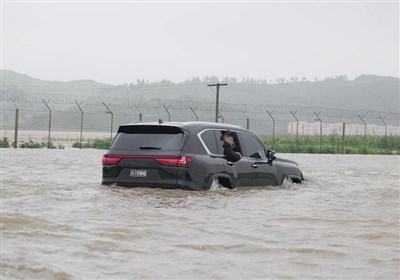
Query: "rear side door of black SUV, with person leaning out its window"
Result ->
[[215, 130, 252, 187]]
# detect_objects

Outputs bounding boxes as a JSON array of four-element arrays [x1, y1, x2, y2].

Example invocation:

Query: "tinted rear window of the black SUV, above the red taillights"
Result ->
[[111, 125, 183, 151]]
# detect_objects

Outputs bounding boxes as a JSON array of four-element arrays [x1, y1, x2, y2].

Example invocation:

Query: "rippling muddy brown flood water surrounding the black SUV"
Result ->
[[1, 149, 400, 279]]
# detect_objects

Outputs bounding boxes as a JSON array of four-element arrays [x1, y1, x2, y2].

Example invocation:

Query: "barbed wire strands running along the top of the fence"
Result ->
[[0, 89, 400, 122]]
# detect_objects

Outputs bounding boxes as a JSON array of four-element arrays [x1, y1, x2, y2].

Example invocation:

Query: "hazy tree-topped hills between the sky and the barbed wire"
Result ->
[[1, 70, 400, 113]]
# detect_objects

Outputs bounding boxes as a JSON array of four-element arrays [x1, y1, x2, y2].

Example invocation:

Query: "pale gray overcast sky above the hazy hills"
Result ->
[[1, 1, 399, 84]]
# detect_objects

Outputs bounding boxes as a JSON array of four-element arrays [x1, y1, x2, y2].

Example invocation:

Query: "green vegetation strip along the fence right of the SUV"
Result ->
[[261, 135, 400, 155]]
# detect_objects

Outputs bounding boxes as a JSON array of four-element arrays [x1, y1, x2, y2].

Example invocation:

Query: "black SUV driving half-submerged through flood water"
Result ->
[[102, 121, 304, 190]]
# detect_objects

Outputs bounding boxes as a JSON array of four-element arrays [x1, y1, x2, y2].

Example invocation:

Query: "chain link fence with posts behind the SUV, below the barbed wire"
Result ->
[[0, 91, 400, 153]]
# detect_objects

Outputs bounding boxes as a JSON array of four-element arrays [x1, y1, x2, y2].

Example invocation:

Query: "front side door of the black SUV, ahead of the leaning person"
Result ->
[[239, 132, 278, 186]]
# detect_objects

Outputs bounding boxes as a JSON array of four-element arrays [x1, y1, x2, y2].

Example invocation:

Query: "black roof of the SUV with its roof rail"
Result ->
[[122, 122, 246, 131]]
